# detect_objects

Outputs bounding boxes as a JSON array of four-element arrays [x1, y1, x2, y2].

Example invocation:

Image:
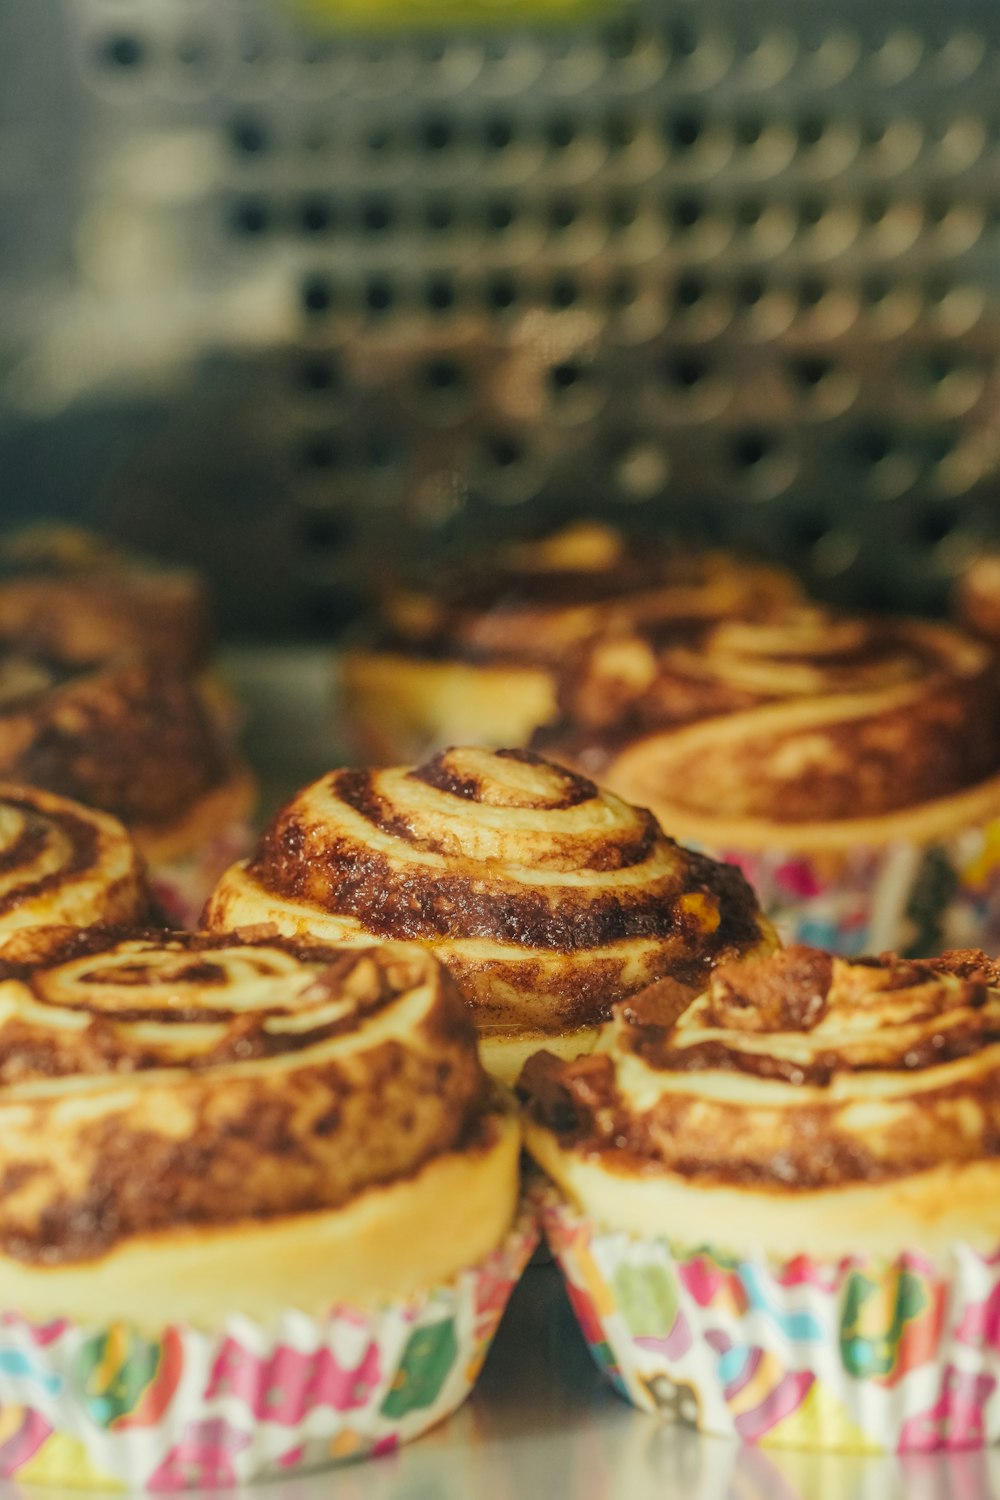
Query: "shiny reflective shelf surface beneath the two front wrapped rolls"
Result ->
[[0, 1265, 1000, 1500]]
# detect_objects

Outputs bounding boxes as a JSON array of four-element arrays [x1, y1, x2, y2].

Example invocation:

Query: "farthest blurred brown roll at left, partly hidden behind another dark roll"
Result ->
[[0, 525, 210, 671]]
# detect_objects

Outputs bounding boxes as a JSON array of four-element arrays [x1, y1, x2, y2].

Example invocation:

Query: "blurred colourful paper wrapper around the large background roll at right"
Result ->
[[706, 819, 1000, 957]]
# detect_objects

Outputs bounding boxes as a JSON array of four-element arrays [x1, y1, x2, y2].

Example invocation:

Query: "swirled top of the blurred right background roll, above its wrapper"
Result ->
[[537, 606, 1000, 846]]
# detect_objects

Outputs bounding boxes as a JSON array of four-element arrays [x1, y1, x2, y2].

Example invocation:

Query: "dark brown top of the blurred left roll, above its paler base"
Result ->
[[0, 654, 254, 849]]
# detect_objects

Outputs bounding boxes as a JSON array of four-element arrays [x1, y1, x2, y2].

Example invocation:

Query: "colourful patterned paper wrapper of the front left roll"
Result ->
[[0, 1208, 538, 1491]]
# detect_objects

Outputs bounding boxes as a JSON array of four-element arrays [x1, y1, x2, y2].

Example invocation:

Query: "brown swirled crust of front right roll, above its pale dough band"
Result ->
[[522, 948, 1000, 1196]]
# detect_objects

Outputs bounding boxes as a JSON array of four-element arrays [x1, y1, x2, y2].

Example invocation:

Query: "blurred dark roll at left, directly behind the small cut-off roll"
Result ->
[[0, 653, 256, 926]]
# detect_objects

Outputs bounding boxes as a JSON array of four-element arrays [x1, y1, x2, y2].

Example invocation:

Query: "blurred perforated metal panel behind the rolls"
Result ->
[[0, 0, 1000, 618]]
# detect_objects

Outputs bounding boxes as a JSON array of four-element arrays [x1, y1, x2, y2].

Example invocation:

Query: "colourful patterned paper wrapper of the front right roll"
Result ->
[[538, 1188, 1000, 1454]]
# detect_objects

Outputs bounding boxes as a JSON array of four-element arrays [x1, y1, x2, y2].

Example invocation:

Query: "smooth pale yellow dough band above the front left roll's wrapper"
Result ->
[[0, 1103, 520, 1334]]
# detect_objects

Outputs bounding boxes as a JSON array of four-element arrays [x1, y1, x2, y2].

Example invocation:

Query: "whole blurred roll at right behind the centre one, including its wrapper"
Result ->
[[532, 605, 1000, 953]]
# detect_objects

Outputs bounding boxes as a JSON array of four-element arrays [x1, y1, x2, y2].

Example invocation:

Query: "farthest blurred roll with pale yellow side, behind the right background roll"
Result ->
[[340, 522, 799, 764]]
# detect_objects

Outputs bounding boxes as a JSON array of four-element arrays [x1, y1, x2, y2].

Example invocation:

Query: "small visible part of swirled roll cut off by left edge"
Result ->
[[0, 783, 148, 945]]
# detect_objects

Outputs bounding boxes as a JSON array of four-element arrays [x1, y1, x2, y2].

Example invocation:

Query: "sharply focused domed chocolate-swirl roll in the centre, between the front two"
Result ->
[[204, 749, 774, 1079]]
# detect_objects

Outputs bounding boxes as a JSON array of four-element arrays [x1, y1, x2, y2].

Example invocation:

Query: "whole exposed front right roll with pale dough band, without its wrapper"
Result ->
[[522, 947, 1000, 1253]]
